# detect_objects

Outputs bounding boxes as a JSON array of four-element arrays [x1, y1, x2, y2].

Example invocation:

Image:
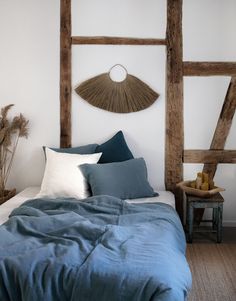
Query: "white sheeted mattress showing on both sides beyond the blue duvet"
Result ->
[[0, 186, 175, 225]]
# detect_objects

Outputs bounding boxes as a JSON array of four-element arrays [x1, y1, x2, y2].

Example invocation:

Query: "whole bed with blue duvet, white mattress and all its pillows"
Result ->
[[0, 132, 191, 301]]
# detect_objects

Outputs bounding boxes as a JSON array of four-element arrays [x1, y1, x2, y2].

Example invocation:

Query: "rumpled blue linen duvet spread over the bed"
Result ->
[[0, 196, 191, 301]]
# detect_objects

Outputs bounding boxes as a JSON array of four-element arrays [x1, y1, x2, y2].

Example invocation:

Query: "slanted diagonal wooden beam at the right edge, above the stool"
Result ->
[[203, 77, 236, 179]]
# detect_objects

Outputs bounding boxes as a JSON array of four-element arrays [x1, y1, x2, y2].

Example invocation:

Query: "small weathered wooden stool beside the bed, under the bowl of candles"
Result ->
[[186, 193, 224, 243]]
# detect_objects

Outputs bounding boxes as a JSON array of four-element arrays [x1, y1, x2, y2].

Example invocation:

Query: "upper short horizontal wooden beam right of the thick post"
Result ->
[[183, 62, 236, 76]]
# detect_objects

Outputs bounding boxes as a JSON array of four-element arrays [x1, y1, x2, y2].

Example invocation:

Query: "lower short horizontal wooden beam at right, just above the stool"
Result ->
[[183, 149, 236, 164]]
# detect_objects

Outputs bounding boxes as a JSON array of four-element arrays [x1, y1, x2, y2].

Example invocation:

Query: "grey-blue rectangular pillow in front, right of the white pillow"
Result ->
[[79, 158, 158, 199]]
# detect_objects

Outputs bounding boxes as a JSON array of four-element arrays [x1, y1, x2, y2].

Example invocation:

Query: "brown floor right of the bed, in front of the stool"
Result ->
[[187, 228, 236, 301]]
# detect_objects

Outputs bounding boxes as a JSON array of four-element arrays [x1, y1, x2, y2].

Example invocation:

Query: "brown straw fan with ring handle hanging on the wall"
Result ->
[[75, 64, 159, 113]]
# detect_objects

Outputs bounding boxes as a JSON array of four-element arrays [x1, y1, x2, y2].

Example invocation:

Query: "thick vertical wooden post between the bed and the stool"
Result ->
[[165, 0, 184, 220]]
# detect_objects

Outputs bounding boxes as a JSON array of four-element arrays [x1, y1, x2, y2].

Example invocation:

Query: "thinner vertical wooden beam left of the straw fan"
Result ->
[[60, 0, 71, 147]]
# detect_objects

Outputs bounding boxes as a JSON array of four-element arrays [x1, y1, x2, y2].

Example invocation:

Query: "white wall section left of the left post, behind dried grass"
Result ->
[[0, 0, 60, 191]]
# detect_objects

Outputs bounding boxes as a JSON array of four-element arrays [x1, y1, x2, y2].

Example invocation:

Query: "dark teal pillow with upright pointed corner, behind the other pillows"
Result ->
[[96, 131, 134, 163]]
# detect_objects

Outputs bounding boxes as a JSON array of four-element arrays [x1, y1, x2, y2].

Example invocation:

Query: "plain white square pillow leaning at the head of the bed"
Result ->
[[37, 148, 102, 199]]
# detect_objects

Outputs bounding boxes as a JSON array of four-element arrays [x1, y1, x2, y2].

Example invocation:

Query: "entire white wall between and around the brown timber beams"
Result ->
[[0, 0, 236, 225]]
